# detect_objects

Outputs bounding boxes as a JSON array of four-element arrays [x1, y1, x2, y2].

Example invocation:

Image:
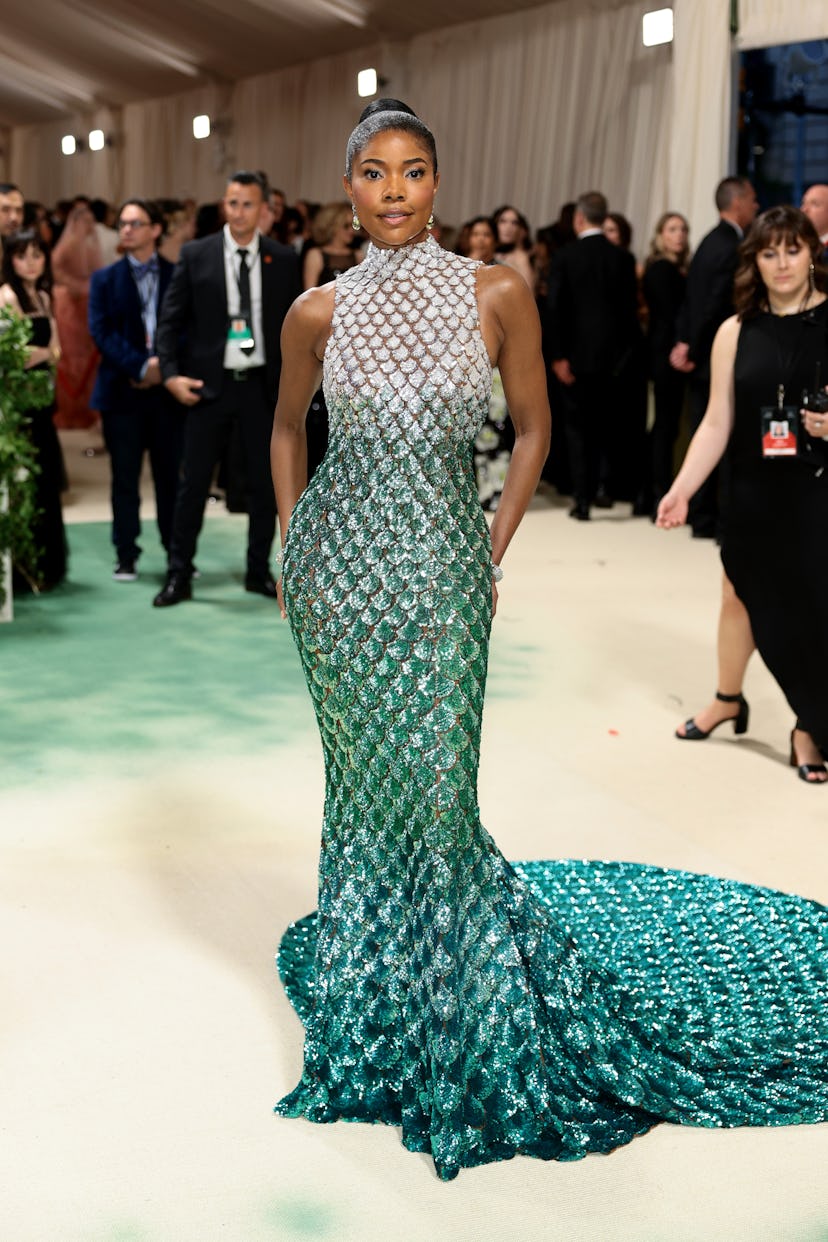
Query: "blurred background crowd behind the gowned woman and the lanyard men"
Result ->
[[0, 174, 828, 585]]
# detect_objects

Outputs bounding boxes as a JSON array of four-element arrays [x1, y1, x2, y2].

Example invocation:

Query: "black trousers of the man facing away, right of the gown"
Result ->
[[560, 374, 618, 508]]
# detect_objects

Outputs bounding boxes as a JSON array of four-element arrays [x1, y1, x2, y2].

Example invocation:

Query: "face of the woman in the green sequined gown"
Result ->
[[344, 129, 439, 248]]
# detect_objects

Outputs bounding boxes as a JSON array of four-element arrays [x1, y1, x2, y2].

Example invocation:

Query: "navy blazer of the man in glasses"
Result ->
[[89, 255, 174, 410]]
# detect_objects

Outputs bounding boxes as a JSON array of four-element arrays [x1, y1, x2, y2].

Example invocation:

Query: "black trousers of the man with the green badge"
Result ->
[[169, 366, 276, 581]]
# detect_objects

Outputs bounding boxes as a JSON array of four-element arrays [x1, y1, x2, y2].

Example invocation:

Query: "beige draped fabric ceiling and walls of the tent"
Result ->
[[0, 0, 828, 255]]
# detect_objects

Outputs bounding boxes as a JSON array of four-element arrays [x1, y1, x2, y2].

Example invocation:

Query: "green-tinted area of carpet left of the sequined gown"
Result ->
[[0, 517, 315, 789]]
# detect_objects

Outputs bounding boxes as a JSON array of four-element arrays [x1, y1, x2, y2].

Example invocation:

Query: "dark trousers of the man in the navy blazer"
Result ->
[[101, 386, 186, 561]]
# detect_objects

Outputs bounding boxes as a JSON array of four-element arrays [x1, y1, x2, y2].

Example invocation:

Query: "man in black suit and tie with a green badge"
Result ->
[[153, 173, 302, 607]]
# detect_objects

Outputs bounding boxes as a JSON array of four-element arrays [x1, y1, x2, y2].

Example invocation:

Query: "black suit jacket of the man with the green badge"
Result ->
[[158, 231, 302, 402]]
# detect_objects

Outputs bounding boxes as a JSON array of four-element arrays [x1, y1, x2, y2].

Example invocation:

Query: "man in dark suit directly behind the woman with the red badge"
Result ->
[[670, 176, 758, 539]]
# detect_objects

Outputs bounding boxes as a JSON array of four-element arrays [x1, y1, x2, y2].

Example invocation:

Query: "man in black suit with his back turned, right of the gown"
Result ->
[[546, 191, 639, 522]]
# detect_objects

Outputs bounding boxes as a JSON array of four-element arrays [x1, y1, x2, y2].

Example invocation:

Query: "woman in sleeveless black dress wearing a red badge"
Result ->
[[658, 207, 828, 784]]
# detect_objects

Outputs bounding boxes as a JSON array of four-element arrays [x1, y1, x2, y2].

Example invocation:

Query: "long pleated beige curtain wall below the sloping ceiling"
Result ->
[[11, 0, 685, 252]]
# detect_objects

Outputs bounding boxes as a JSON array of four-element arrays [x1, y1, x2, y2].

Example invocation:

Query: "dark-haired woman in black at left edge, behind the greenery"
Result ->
[[0, 229, 67, 590]]
